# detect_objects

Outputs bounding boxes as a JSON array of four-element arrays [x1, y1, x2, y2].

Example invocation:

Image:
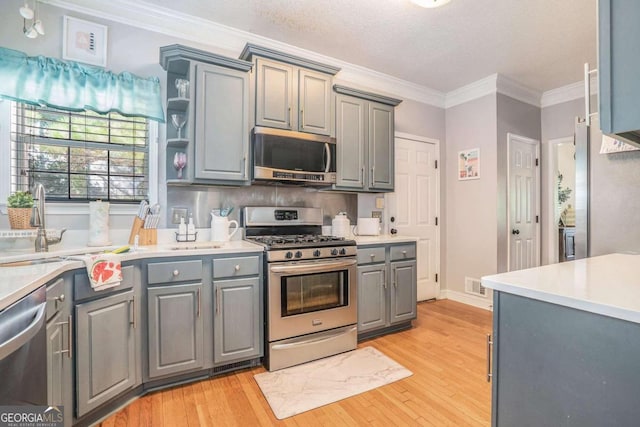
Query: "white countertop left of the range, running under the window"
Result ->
[[0, 240, 264, 310]]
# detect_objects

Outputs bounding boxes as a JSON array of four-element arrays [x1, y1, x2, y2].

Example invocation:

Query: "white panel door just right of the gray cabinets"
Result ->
[[387, 135, 440, 301]]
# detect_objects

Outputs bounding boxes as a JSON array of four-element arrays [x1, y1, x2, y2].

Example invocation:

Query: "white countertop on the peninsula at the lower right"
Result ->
[[482, 254, 640, 323]]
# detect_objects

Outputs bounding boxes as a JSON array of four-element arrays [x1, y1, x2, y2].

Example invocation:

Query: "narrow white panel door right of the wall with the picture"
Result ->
[[508, 134, 540, 271]]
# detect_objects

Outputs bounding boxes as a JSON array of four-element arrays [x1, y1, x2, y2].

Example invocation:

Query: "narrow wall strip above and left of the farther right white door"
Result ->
[[495, 93, 542, 273]]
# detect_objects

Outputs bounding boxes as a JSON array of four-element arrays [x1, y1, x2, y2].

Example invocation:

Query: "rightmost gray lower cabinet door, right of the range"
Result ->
[[389, 260, 418, 324]]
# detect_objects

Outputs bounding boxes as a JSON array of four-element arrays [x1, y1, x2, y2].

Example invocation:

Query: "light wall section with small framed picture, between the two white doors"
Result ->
[[441, 94, 497, 298]]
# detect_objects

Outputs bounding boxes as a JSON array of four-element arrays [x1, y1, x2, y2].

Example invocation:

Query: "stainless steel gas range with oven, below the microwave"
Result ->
[[243, 207, 358, 371]]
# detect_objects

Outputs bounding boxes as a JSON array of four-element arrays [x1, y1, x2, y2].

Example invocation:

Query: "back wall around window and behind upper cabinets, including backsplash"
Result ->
[[0, 0, 444, 236]]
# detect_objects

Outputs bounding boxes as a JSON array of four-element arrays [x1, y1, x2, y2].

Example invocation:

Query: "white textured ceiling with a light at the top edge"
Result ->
[[144, 0, 597, 92]]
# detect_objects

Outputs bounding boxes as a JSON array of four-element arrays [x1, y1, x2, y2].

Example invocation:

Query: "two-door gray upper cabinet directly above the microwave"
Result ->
[[240, 44, 340, 135]]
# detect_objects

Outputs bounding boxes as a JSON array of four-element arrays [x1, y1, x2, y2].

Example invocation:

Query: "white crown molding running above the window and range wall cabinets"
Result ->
[[40, 0, 445, 108]]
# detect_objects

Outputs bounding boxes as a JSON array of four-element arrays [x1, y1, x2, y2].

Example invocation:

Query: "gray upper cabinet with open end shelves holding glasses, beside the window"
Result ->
[[160, 45, 252, 185]]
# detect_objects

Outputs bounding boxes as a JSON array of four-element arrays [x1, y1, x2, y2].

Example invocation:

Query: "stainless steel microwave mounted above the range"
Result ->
[[251, 126, 336, 186]]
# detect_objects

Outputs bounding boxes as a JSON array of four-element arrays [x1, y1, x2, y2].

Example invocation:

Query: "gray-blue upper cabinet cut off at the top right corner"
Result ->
[[598, 0, 640, 147]]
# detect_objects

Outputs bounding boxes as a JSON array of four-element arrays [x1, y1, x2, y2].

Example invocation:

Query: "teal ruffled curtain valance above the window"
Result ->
[[0, 47, 165, 123]]
